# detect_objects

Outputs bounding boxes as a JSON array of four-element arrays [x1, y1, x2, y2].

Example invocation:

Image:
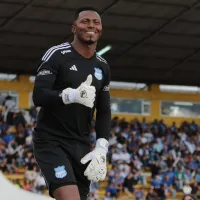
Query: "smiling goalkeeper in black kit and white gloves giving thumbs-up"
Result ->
[[33, 7, 111, 200]]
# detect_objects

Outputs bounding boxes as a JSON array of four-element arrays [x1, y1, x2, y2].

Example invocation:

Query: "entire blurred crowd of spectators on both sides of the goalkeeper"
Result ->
[[0, 95, 200, 200]]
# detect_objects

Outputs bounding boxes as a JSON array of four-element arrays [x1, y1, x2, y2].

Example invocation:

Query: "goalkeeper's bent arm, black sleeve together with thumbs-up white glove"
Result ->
[[33, 55, 95, 108]]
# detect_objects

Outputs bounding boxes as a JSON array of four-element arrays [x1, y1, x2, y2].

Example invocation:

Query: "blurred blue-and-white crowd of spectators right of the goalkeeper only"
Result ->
[[88, 117, 200, 200]]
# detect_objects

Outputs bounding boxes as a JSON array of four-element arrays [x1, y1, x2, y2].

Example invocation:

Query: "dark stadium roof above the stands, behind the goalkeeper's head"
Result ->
[[0, 0, 200, 85]]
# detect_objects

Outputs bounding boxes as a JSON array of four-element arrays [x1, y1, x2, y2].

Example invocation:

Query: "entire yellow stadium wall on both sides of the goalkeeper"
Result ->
[[0, 75, 200, 125]]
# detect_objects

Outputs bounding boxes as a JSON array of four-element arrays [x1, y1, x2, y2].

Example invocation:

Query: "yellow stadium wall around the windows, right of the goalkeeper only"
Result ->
[[111, 84, 200, 125]]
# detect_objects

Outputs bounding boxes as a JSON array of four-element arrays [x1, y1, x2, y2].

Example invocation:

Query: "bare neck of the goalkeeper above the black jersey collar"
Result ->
[[71, 39, 97, 58]]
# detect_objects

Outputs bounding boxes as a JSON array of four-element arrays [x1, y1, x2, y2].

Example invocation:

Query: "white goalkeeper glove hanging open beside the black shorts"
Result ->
[[81, 138, 108, 182]]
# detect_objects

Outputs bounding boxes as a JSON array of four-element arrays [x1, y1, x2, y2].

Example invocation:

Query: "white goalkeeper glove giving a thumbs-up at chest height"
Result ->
[[61, 74, 96, 108]]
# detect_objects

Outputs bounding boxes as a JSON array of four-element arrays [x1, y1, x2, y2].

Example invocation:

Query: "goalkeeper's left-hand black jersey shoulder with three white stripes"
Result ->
[[42, 42, 71, 62]]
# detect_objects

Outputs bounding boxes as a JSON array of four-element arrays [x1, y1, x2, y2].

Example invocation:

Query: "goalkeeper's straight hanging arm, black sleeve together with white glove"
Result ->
[[81, 65, 111, 182]]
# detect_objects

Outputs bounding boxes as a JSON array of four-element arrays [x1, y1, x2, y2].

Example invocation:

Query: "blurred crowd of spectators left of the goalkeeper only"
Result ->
[[0, 96, 46, 193]]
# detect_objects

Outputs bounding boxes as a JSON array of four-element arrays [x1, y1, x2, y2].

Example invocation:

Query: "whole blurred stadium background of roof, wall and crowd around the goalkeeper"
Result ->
[[0, 0, 200, 200]]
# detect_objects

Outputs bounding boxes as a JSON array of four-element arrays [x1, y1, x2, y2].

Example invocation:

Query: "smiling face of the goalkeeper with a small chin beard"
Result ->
[[72, 11, 102, 45]]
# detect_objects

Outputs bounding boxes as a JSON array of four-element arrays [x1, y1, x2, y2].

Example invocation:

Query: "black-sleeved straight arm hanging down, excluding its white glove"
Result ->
[[95, 65, 111, 140]]
